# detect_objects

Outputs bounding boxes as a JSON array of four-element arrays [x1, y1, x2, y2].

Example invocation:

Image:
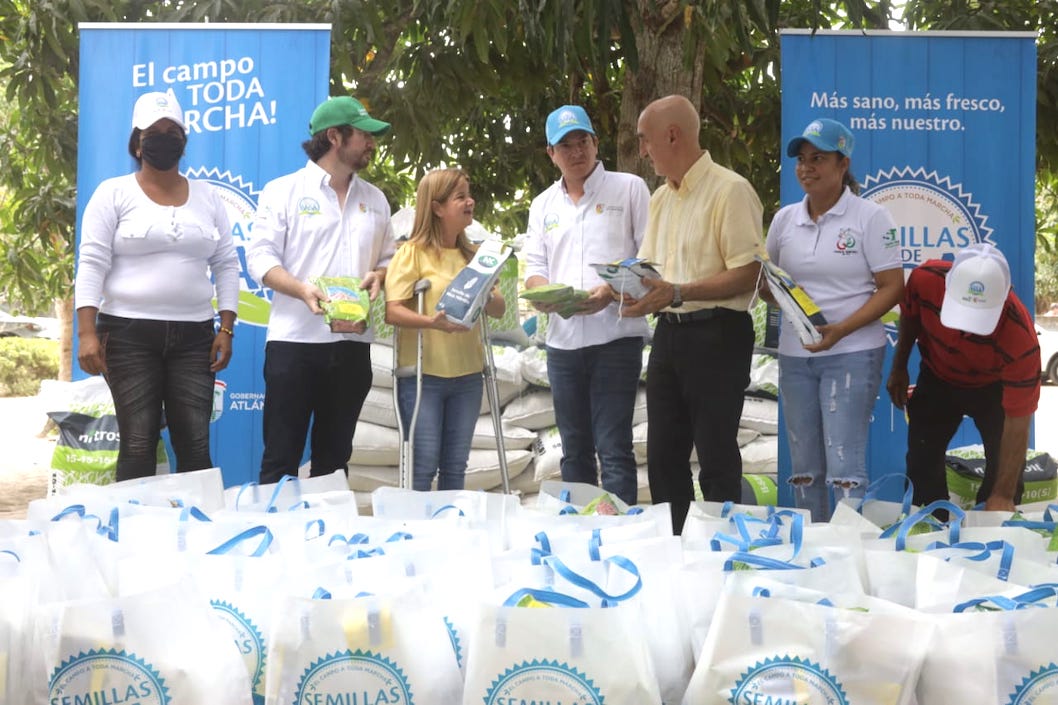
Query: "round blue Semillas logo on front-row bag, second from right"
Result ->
[[730, 656, 849, 705]]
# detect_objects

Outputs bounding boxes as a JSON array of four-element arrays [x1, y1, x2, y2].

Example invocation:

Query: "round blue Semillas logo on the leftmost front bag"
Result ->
[[48, 649, 171, 705]]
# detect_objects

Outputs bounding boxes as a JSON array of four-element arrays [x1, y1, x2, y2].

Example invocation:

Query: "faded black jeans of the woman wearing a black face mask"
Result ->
[[95, 313, 214, 481]]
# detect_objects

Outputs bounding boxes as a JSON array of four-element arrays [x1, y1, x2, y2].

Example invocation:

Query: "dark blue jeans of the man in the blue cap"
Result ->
[[547, 337, 643, 505]]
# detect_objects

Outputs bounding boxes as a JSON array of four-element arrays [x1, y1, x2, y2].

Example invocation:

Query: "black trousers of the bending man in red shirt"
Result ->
[[908, 364, 1024, 507]]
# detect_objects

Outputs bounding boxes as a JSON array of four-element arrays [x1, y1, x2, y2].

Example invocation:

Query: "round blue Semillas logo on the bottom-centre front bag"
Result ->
[[485, 658, 603, 705]]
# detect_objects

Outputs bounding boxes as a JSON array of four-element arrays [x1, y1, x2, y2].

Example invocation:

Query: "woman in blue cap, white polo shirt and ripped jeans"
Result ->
[[766, 119, 904, 521]]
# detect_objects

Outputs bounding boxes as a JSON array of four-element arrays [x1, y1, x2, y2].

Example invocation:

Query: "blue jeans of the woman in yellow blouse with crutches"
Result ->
[[397, 373, 484, 491]]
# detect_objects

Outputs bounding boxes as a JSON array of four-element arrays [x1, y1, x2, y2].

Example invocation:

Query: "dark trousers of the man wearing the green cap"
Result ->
[[260, 341, 371, 484]]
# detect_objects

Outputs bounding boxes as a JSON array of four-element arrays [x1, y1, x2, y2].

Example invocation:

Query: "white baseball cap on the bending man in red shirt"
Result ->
[[941, 242, 1010, 336]]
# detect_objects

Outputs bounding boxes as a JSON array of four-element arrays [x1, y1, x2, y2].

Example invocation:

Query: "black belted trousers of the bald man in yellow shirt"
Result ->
[[646, 309, 753, 534]]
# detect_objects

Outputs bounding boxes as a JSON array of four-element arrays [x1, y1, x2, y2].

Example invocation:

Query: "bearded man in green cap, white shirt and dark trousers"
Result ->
[[247, 96, 396, 484]]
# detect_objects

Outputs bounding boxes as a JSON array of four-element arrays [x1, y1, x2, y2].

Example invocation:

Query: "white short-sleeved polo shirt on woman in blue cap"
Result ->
[[765, 187, 902, 357]]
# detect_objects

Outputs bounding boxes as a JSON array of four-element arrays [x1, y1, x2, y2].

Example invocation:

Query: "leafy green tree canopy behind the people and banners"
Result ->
[[0, 0, 1058, 309]]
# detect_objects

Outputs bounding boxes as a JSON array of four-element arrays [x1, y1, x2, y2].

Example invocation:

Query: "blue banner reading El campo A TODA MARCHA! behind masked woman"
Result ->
[[74, 23, 330, 485]]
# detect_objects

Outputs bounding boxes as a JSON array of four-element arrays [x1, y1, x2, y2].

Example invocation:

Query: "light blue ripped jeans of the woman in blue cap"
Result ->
[[779, 347, 886, 522]]
